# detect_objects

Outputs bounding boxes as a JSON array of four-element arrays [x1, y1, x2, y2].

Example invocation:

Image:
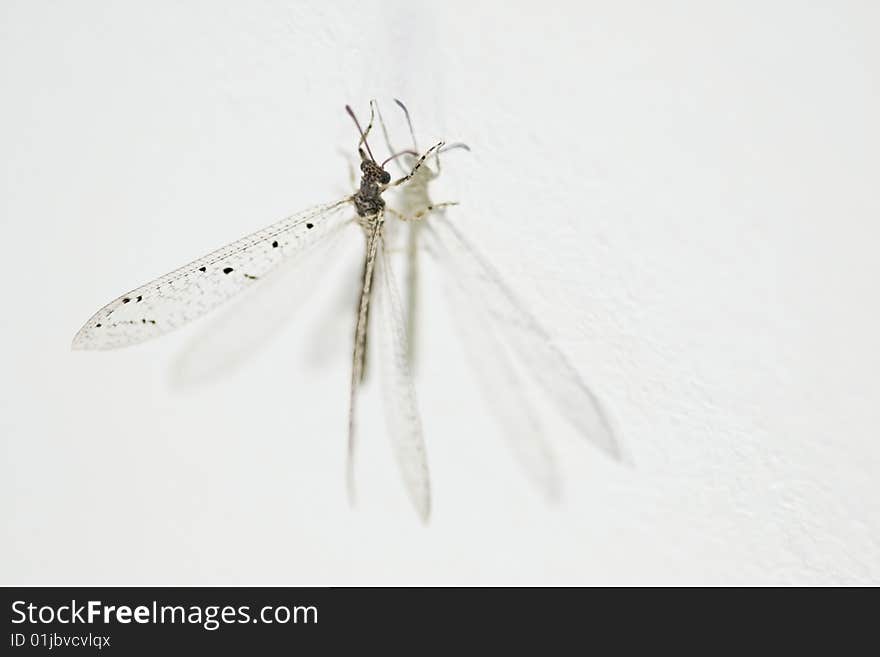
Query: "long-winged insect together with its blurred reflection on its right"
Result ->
[[73, 101, 621, 521]]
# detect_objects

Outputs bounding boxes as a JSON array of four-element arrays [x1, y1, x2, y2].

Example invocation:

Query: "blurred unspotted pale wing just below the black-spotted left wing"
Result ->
[[172, 222, 347, 386]]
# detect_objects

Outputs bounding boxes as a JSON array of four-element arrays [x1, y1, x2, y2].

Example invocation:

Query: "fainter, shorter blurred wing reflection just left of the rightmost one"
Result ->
[[445, 271, 560, 500]]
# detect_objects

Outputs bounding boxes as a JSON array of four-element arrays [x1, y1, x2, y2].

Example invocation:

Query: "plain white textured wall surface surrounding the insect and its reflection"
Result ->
[[0, 0, 880, 584]]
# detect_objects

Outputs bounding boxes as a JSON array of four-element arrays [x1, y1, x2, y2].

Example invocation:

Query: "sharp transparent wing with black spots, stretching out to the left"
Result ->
[[73, 198, 350, 349]]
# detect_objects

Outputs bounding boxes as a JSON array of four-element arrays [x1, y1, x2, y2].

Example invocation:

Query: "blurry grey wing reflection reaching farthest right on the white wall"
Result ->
[[426, 215, 626, 460]]
